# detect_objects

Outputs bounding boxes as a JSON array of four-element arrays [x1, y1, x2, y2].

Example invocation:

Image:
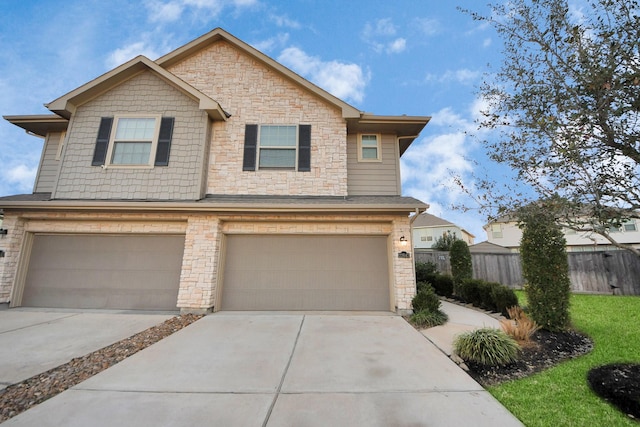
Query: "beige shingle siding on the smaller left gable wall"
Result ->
[[52, 71, 208, 200]]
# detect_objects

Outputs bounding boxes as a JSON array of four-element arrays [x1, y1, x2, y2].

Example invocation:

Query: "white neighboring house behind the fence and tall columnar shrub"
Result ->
[[484, 219, 640, 252]]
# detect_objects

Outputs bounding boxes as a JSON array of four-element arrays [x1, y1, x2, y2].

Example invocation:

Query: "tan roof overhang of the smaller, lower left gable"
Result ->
[[45, 55, 229, 120]]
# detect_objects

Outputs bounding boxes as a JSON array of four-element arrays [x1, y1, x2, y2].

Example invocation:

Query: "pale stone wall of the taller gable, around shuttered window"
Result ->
[[168, 41, 347, 196]]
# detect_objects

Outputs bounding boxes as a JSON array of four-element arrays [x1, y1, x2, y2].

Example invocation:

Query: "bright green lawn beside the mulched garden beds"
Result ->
[[489, 293, 640, 427]]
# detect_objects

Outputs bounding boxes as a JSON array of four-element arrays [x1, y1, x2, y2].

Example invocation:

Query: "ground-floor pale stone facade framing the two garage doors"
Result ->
[[0, 212, 415, 312]]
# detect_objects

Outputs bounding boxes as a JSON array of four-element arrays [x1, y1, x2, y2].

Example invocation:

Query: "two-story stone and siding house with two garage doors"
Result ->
[[0, 29, 429, 312]]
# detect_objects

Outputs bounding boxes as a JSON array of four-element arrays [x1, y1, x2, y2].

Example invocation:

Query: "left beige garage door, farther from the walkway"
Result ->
[[22, 235, 184, 310]]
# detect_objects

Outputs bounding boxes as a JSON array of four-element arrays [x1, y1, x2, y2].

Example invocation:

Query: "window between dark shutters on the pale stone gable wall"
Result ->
[[258, 125, 298, 170]]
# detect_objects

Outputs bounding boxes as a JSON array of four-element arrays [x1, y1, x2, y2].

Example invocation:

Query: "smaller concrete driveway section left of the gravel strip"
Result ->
[[0, 309, 171, 390]]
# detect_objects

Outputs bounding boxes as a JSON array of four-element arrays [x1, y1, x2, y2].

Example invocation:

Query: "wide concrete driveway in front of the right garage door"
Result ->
[[6, 313, 522, 427]]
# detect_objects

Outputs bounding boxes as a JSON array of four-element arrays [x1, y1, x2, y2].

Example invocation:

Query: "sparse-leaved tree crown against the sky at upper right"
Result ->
[[464, 0, 640, 256]]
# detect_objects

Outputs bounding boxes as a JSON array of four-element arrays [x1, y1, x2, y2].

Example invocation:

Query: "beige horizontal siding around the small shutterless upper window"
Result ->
[[347, 135, 400, 196]]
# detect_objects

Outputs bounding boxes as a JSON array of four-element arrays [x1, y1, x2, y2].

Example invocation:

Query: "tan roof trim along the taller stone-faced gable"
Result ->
[[156, 28, 362, 119]]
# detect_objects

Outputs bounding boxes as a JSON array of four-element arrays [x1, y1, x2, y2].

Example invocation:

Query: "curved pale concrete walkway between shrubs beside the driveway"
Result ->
[[421, 301, 508, 357]]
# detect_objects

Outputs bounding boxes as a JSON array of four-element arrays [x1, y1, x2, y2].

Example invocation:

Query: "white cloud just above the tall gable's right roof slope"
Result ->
[[278, 47, 369, 102]]
